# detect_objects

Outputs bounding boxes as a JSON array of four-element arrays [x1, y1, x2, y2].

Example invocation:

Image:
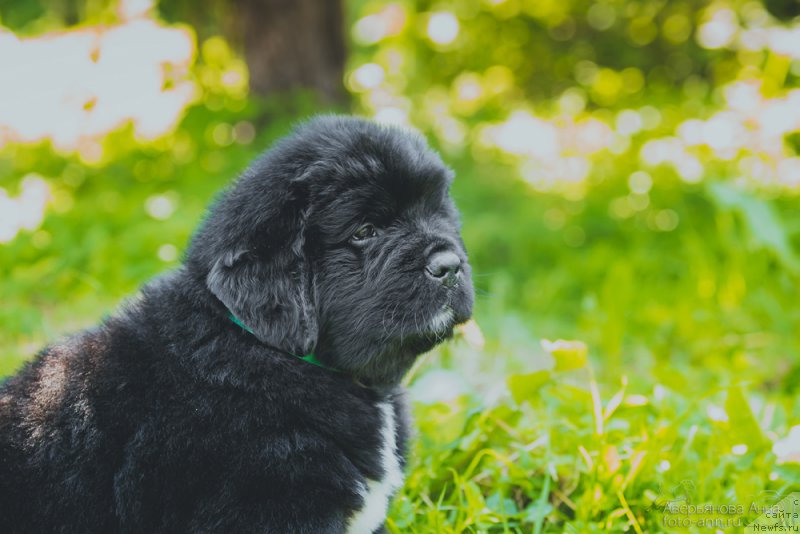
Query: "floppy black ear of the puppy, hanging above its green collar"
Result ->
[[206, 180, 317, 354]]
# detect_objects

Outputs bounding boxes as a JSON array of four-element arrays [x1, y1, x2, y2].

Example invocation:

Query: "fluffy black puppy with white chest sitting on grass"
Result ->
[[0, 117, 473, 534]]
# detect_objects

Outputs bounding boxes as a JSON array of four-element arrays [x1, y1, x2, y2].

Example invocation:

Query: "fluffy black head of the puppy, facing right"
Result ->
[[189, 117, 473, 384]]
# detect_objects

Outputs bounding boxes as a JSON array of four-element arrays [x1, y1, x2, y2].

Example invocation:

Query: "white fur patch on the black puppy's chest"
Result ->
[[347, 402, 403, 534]]
